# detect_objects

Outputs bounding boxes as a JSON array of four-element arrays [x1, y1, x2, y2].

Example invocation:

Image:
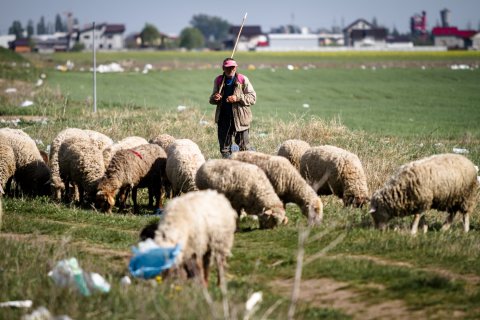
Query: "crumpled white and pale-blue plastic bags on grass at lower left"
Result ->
[[48, 258, 110, 296]]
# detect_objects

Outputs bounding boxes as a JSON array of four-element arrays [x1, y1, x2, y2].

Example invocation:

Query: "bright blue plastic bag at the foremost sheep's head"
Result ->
[[128, 238, 181, 279]]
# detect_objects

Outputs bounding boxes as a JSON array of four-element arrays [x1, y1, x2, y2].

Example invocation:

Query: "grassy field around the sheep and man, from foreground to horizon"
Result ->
[[0, 51, 480, 319]]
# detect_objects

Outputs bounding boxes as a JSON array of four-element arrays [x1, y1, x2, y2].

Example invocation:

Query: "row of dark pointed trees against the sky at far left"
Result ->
[[8, 14, 71, 38]]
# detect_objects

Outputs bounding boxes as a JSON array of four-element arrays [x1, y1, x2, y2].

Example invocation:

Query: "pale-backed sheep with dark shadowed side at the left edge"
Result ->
[[0, 128, 50, 196]]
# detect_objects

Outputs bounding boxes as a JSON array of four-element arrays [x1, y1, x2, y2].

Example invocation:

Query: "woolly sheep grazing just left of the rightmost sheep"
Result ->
[[300, 145, 369, 207]]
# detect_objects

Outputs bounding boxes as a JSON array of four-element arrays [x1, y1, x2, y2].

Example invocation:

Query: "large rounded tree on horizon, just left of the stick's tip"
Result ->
[[190, 14, 231, 47]]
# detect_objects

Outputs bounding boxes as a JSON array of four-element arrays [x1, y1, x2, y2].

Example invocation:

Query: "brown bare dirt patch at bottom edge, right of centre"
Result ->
[[271, 278, 427, 320]]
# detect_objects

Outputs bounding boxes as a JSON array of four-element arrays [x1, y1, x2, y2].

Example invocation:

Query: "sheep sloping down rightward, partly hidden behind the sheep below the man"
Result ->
[[231, 151, 323, 225]]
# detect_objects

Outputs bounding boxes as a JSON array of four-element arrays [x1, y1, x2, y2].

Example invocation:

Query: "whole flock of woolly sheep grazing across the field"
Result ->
[[0, 128, 478, 284]]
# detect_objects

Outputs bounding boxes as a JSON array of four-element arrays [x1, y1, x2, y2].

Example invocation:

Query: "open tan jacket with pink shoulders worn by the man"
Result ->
[[209, 74, 257, 131]]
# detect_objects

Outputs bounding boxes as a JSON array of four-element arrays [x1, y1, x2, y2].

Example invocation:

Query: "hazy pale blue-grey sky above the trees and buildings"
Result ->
[[0, 0, 480, 35]]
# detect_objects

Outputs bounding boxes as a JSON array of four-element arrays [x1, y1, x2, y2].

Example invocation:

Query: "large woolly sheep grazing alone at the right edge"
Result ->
[[370, 153, 479, 234]]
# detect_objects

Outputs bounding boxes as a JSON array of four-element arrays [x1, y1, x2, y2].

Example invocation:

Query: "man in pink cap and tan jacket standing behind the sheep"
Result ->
[[210, 58, 257, 158]]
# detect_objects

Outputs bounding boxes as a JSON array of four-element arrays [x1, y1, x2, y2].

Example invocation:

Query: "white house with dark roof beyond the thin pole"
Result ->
[[77, 23, 125, 50]]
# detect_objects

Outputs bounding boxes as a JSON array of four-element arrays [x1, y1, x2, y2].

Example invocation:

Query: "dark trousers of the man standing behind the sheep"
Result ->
[[218, 118, 250, 158]]
